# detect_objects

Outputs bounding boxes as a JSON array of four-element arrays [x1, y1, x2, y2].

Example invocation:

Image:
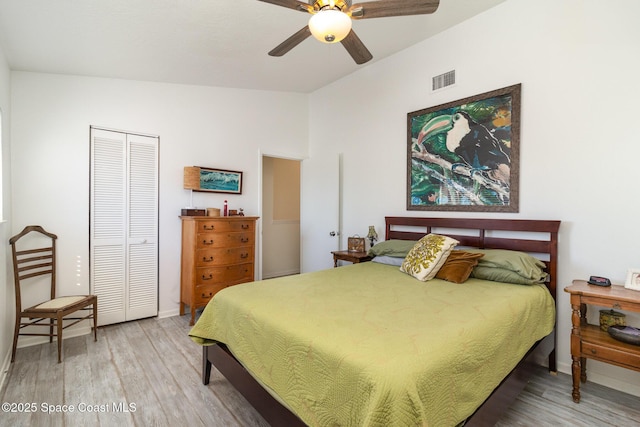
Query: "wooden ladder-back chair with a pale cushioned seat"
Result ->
[[9, 225, 98, 363]]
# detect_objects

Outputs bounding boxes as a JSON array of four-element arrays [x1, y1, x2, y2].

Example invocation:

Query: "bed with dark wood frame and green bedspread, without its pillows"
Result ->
[[190, 217, 560, 426]]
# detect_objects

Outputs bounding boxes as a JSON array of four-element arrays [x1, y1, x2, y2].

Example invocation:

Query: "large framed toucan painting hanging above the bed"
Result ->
[[407, 84, 521, 212]]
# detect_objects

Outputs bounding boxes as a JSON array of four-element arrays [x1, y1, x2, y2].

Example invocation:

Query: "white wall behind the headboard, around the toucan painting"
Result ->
[[309, 0, 640, 395]]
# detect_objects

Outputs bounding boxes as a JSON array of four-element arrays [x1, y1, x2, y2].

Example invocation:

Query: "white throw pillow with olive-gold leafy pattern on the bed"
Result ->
[[400, 234, 459, 282]]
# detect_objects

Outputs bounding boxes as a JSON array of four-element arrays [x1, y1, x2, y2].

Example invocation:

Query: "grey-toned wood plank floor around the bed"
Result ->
[[0, 316, 640, 427]]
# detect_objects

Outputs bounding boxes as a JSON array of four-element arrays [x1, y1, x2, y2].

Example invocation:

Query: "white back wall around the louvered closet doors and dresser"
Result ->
[[11, 72, 308, 326]]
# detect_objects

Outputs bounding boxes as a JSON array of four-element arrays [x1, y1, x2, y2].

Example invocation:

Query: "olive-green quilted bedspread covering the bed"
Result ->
[[189, 262, 555, 426]]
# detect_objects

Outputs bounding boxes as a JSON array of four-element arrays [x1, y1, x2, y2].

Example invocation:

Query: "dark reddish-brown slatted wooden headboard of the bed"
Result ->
[[385, 216, 560, 299]]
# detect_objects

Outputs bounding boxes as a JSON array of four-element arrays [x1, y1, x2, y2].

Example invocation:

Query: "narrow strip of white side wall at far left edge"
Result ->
[[0, 36, 15, 387]]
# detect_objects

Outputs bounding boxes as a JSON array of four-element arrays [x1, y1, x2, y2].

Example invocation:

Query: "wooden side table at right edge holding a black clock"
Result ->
[[564, 280, 640, 403]]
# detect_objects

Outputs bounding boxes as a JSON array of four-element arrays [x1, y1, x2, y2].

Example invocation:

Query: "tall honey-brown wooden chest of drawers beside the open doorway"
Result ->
[[180, 216, 258, 325]]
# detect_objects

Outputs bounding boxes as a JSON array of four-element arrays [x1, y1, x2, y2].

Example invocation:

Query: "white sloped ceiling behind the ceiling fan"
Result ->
[[0, 0, 505, 93]]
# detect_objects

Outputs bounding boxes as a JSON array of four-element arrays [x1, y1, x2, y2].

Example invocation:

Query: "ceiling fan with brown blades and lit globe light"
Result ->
[[260, 0, 440, 64]]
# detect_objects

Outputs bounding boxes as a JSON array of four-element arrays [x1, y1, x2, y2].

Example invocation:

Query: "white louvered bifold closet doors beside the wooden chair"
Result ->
[[90, 128, 158, 325]]
